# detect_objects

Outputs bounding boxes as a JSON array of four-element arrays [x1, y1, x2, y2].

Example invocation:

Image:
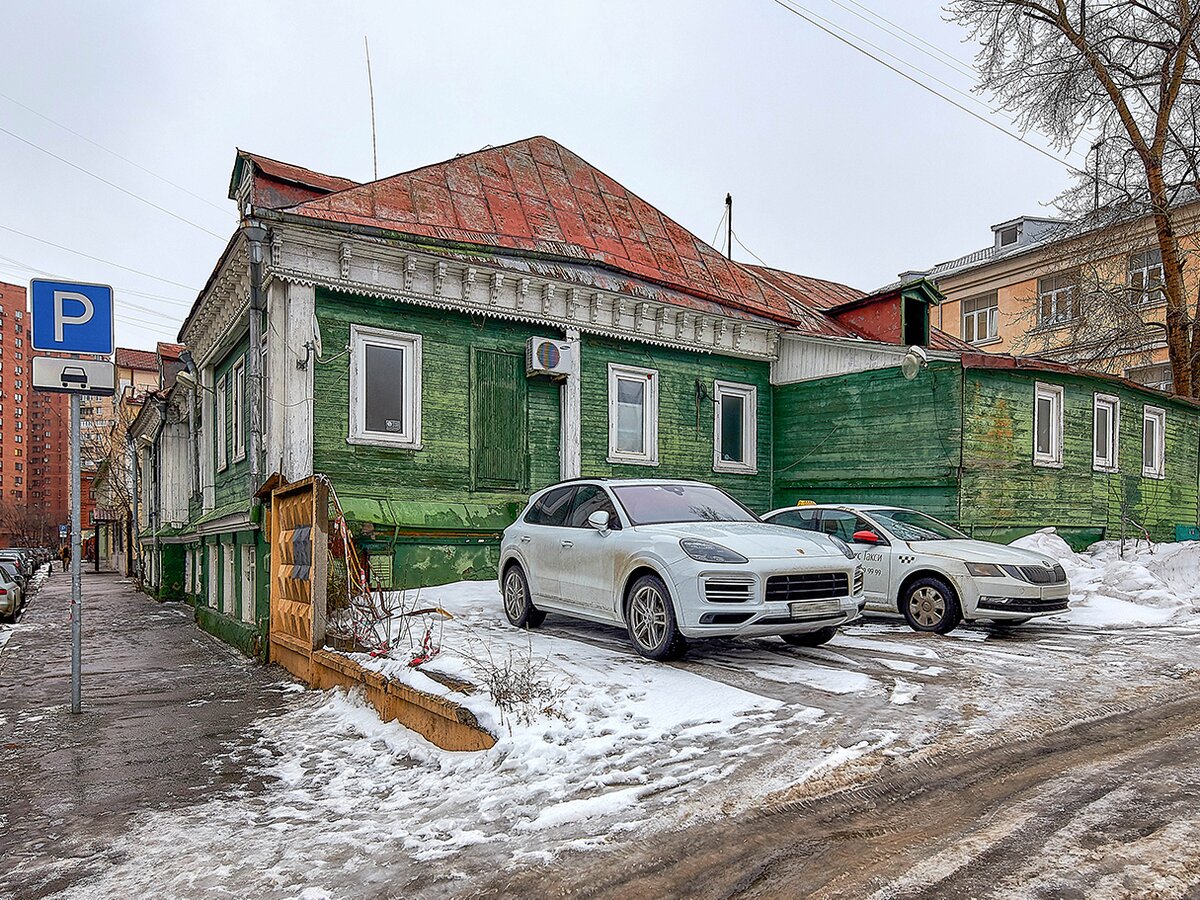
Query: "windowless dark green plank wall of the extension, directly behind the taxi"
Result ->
[[774, 362, 962, 522]]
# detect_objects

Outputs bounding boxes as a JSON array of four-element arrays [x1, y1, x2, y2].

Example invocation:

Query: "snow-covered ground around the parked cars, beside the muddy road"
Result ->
[[60, 534, 1200, 898]]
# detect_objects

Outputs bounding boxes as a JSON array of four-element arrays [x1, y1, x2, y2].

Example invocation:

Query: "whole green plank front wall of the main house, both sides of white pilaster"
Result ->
[[313, 289, 772, 586]]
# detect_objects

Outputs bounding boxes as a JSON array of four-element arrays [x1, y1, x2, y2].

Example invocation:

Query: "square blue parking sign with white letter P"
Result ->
[[29, 278, 113, 356]]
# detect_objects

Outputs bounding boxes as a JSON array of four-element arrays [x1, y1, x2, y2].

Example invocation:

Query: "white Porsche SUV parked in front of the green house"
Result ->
[[499, 479, 863, 660]]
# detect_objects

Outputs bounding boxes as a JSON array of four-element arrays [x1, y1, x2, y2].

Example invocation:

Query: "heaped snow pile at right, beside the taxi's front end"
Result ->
[[1013, 529, 1200, 628]]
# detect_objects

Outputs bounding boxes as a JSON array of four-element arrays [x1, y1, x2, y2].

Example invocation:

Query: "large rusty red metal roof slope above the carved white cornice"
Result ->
[[290, 137, 825, 324]]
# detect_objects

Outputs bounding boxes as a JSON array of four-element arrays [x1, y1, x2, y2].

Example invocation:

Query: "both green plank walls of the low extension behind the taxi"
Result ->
[[774, 361, 1200, 548]]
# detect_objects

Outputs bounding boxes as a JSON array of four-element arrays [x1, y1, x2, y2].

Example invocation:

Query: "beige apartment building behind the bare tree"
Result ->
[[930, 203, 1200, 390]]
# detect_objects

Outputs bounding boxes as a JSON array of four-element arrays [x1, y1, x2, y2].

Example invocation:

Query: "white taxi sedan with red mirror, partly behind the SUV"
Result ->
[[763, 504, 1070, 635]]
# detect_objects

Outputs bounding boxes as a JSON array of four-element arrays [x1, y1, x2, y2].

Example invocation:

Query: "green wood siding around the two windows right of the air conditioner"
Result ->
[[580, 335, 772, 512]]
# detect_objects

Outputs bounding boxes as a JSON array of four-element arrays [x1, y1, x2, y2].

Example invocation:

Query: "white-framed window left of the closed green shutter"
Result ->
[[349, 325, 421, 450]]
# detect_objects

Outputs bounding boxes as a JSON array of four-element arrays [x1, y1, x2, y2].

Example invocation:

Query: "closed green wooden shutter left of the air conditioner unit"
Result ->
[[470, 348, 528, 490]]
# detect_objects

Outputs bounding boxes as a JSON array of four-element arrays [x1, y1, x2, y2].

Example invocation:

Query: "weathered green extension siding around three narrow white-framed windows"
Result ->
[[962, 370, 1200, 544]]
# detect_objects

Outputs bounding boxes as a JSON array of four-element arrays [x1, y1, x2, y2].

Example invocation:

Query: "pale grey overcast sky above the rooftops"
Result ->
[[0, 0, 1081, 347]]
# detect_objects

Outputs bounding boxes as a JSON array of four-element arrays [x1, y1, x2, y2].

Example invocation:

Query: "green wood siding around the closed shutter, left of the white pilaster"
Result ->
[[313, 290, 559, 530]]
